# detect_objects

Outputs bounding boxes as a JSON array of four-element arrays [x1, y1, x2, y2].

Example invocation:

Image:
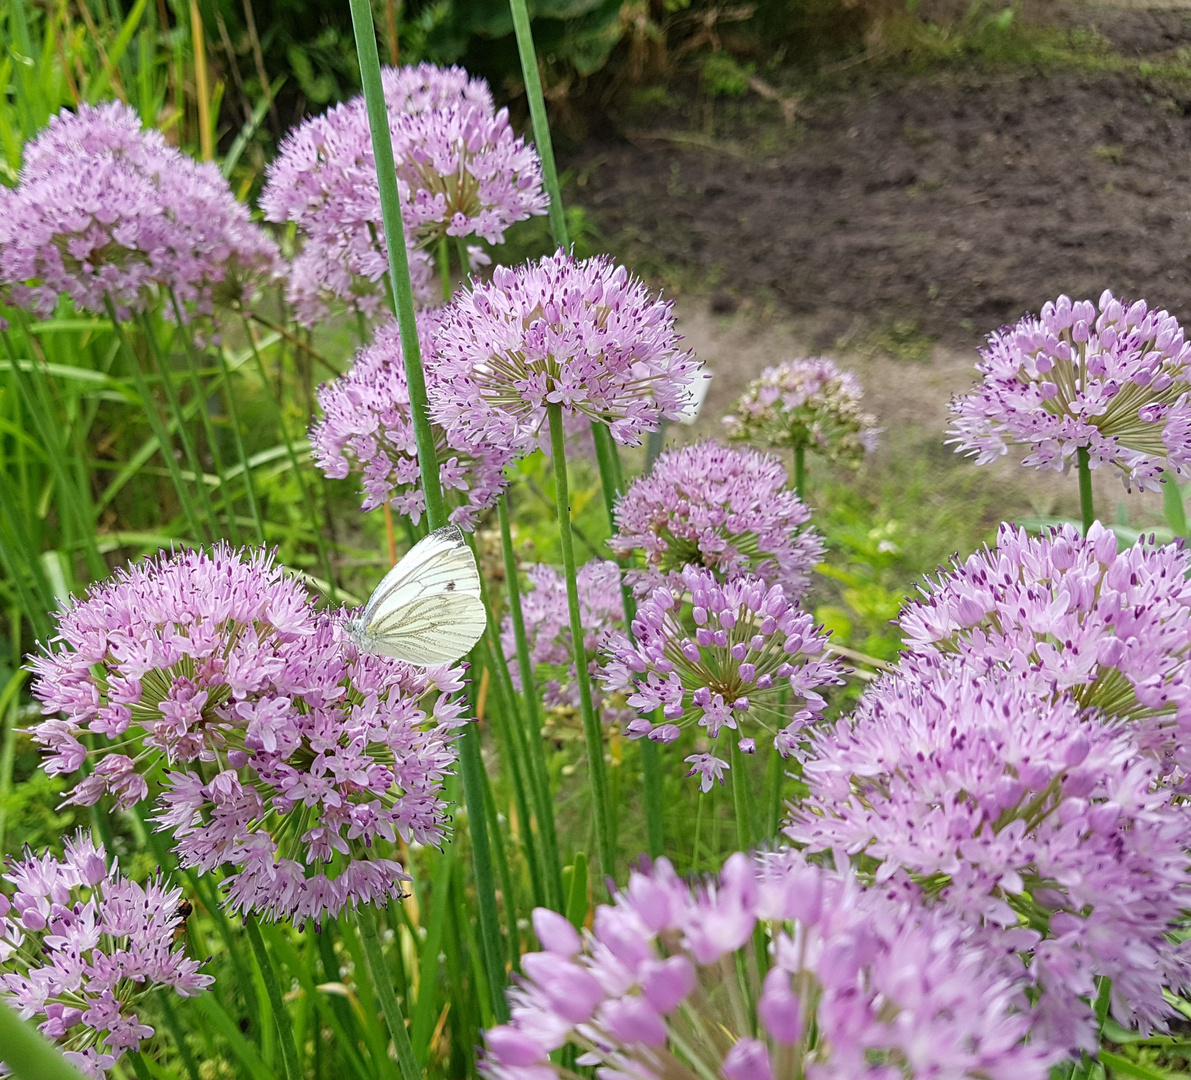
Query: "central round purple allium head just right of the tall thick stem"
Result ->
[[430, 250, 697, 444]]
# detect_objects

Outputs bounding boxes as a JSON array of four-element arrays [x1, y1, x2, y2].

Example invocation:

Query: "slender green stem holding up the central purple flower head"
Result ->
[[545, 402, 616, 878]]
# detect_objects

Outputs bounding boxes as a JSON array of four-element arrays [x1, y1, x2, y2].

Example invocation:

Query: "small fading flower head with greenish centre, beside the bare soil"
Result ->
[[724, 357, 880, 467]]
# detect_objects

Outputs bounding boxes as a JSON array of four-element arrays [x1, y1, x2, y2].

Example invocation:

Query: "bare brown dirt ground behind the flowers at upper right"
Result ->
[[566, 8, 1191, 524]]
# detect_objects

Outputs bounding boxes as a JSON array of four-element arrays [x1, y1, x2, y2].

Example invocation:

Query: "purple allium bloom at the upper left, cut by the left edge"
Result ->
[[0, 101, 280, 318]]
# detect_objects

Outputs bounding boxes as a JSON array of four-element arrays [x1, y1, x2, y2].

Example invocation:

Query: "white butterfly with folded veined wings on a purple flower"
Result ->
[[345, 525, 487, 667]]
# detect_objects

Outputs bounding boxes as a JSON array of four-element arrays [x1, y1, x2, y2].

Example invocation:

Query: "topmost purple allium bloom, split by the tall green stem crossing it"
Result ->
[[261, 64, 545, 324]]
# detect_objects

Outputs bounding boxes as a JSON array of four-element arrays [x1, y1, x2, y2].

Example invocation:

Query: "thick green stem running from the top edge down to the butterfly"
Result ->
[[350, 0, 450, 528]]
